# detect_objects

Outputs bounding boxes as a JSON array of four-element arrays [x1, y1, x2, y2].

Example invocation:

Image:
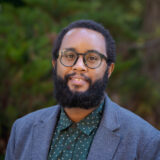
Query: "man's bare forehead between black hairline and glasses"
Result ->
[[60, 28, 106, 55]]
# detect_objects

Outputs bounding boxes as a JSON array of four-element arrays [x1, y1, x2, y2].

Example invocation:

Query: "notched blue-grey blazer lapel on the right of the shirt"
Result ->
[[87, 96, 120, 160]]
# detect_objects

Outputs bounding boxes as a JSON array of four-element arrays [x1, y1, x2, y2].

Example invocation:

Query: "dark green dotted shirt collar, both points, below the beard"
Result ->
[[58, 101, 104, 135]]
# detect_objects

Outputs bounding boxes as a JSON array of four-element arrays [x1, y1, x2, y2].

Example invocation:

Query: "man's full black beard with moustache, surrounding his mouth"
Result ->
[[53, 67, 108, 109]]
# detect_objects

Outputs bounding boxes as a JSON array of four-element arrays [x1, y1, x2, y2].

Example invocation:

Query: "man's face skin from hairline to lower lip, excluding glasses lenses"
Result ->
[[56, 28, 107, 92]]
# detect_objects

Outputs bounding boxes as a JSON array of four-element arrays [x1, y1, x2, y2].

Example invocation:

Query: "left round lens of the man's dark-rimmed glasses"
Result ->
[[61, 50, 77, 66]]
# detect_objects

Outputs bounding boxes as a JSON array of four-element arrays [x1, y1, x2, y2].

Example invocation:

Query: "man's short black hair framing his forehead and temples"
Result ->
[[52, 20, 116, 65]]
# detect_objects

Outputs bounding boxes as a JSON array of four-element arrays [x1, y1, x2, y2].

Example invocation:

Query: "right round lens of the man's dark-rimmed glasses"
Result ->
[[85, 52, 101, 68]]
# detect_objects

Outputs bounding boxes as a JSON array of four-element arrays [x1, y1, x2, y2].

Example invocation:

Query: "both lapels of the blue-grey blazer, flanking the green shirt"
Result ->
[[32, 95, 120, 160]]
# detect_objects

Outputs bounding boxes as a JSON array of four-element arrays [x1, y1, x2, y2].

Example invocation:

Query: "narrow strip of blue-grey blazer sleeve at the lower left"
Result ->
[[5, 123, 16, 160]]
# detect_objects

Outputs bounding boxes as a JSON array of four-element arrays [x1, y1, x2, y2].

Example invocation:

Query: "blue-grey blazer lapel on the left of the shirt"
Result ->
[[32, 106, 60, 160]]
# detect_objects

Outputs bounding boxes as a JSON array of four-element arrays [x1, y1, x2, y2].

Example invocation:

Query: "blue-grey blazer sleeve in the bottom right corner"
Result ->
[[140, 134, 160, 160]]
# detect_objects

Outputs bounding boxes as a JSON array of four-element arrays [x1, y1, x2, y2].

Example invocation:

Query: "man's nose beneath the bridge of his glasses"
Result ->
[[72, 56, 87, 72]]
